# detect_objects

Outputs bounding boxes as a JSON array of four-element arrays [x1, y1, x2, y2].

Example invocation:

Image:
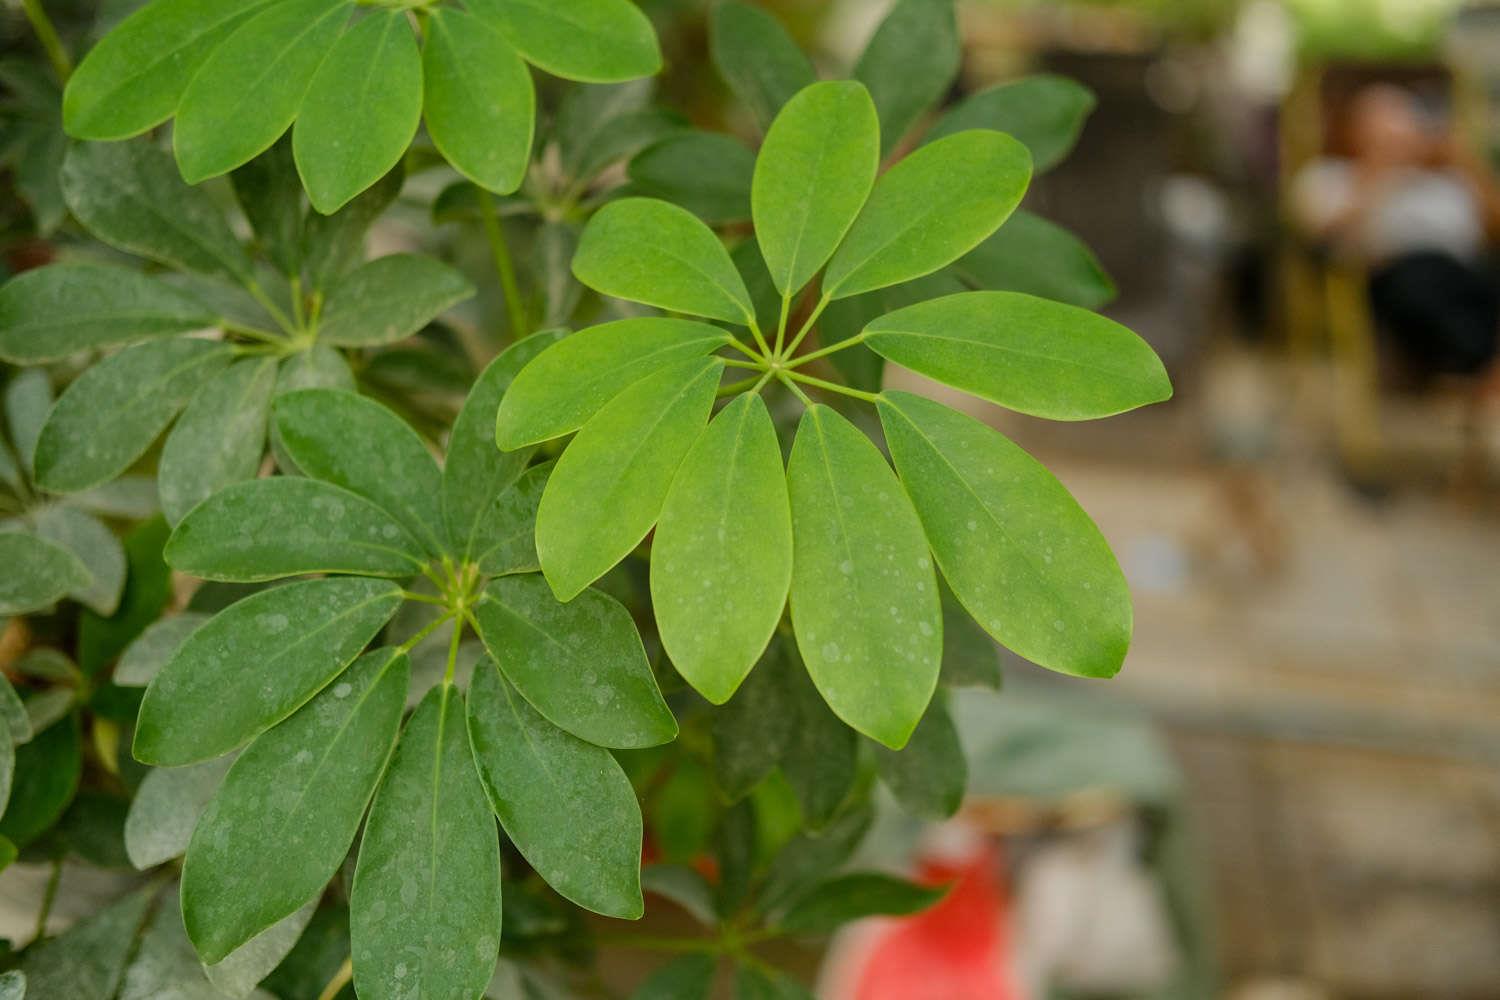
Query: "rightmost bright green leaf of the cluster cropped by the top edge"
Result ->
[[470, 0, 662, 84]]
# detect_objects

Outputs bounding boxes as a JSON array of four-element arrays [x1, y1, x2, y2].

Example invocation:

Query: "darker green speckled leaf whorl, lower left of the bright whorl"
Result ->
[[134, 340, 677, 1000]]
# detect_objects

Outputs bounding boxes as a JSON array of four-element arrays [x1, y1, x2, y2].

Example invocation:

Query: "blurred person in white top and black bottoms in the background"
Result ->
[[1293, 84, 1500, 375]]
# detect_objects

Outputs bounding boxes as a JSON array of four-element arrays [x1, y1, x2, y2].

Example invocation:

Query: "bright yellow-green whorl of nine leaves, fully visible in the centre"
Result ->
[[497, 81, 1172, 748]]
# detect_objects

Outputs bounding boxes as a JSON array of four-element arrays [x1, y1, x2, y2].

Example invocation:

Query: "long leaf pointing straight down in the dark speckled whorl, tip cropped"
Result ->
[[350, 684, 501, 1000]]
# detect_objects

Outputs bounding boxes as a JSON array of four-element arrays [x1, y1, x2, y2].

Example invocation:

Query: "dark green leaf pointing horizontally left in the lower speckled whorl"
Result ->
[[165, 475, 426, 583]]
